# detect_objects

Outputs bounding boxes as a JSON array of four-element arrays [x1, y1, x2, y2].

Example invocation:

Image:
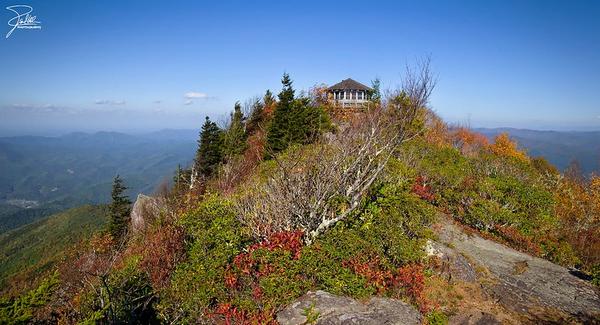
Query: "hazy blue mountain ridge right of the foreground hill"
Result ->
[[475, 128, 600, 174]]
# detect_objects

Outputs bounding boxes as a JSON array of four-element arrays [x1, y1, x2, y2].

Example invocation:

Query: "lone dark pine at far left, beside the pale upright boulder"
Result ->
[[108, 175, 131, 239]]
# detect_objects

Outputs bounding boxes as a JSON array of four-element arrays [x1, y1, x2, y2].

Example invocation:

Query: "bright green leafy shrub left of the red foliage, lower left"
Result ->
[[158, 196, 247, 322]]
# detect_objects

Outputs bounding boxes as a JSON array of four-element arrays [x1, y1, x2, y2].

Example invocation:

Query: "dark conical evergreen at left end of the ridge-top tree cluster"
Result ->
[[194, 116, 223, 178]]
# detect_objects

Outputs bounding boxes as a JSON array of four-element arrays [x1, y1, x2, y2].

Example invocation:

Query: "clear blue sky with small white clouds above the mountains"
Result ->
[[0, 0, 600, 135]]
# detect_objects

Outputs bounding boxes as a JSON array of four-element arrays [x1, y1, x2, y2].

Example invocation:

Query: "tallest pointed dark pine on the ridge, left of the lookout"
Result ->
[[265, 73, 295, 158]]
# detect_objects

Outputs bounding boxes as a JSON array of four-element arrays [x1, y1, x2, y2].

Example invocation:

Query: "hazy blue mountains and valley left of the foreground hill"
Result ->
[[0, 130, 198, 233]]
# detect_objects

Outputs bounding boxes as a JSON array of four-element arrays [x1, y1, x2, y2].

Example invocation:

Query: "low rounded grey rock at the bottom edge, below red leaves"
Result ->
[[277, 291, 422, 325]]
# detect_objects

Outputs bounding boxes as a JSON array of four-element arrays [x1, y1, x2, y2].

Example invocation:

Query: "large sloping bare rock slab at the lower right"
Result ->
[[432, 220, 600, 323]]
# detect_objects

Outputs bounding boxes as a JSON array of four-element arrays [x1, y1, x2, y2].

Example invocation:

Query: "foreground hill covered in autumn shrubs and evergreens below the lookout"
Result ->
[[0, 67, 600, 324]]
